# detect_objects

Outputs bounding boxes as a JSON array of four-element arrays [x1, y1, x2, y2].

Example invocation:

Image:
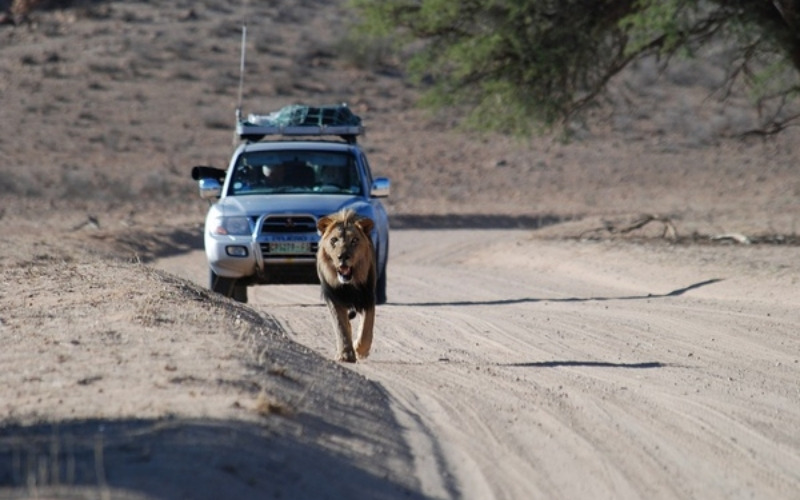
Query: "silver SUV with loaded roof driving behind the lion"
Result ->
[[192, 106, 390, 304]]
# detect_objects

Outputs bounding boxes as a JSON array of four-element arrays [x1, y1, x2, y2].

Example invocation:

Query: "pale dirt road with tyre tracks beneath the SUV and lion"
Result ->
[[159, 230, 800, 499]]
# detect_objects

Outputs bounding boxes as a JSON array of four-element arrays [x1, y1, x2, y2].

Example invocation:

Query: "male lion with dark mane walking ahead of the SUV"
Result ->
[[317, 210, 377, 363]]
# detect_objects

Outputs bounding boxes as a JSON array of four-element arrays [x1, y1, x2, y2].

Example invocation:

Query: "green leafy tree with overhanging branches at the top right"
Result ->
[[352, 0, 800, 133]]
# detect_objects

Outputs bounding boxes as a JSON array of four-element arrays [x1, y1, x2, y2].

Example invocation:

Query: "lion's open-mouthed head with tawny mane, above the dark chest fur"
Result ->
[[317, 211, 374, 284]]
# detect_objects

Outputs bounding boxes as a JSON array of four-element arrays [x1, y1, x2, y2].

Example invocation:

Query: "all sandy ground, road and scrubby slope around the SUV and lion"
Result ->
[[0, 0, 800, 499]]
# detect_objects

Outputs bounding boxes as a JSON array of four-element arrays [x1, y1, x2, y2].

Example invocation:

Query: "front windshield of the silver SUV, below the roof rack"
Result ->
[[229, 151, 361, 195]]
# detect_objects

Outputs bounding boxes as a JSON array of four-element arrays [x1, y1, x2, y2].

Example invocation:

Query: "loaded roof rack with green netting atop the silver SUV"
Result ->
[[236, 104, 364, 143]]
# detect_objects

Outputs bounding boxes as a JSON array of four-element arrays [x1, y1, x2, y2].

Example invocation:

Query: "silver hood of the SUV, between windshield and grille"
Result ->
[[217, 194, 370, 217]]
